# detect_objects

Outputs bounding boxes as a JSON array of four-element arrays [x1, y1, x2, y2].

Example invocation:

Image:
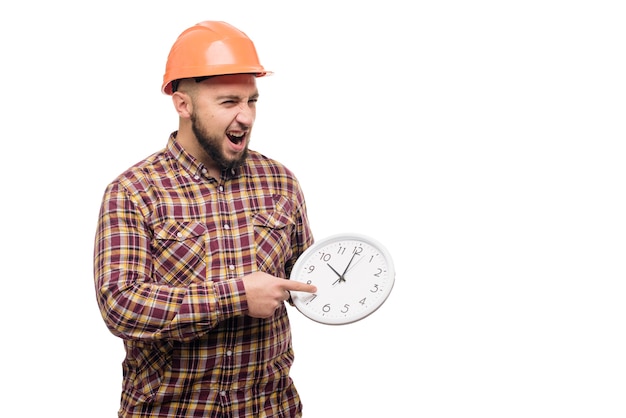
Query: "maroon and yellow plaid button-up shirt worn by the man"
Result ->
[[94, 133, 313, 418]]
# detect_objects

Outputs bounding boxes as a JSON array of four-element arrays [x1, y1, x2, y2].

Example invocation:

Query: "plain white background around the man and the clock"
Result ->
[[0, 0, 626, 418]]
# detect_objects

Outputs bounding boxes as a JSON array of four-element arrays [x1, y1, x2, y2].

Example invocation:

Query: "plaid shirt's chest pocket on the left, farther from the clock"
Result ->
[[153, 221, 207, 286]]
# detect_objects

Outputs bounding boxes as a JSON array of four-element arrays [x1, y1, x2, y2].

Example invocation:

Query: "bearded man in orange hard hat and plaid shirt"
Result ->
[[94, 21, 316, 418]]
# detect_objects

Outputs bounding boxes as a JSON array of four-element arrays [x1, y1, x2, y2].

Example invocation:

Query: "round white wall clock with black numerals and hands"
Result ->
[[290, 234, 395, 325]]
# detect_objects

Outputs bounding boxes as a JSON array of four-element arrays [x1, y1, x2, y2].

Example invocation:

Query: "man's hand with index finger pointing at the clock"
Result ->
[[243, 271, 317, 318]]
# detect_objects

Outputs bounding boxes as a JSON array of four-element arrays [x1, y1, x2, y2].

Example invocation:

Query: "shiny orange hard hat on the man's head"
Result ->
[[161, 20, 271, 94]]
